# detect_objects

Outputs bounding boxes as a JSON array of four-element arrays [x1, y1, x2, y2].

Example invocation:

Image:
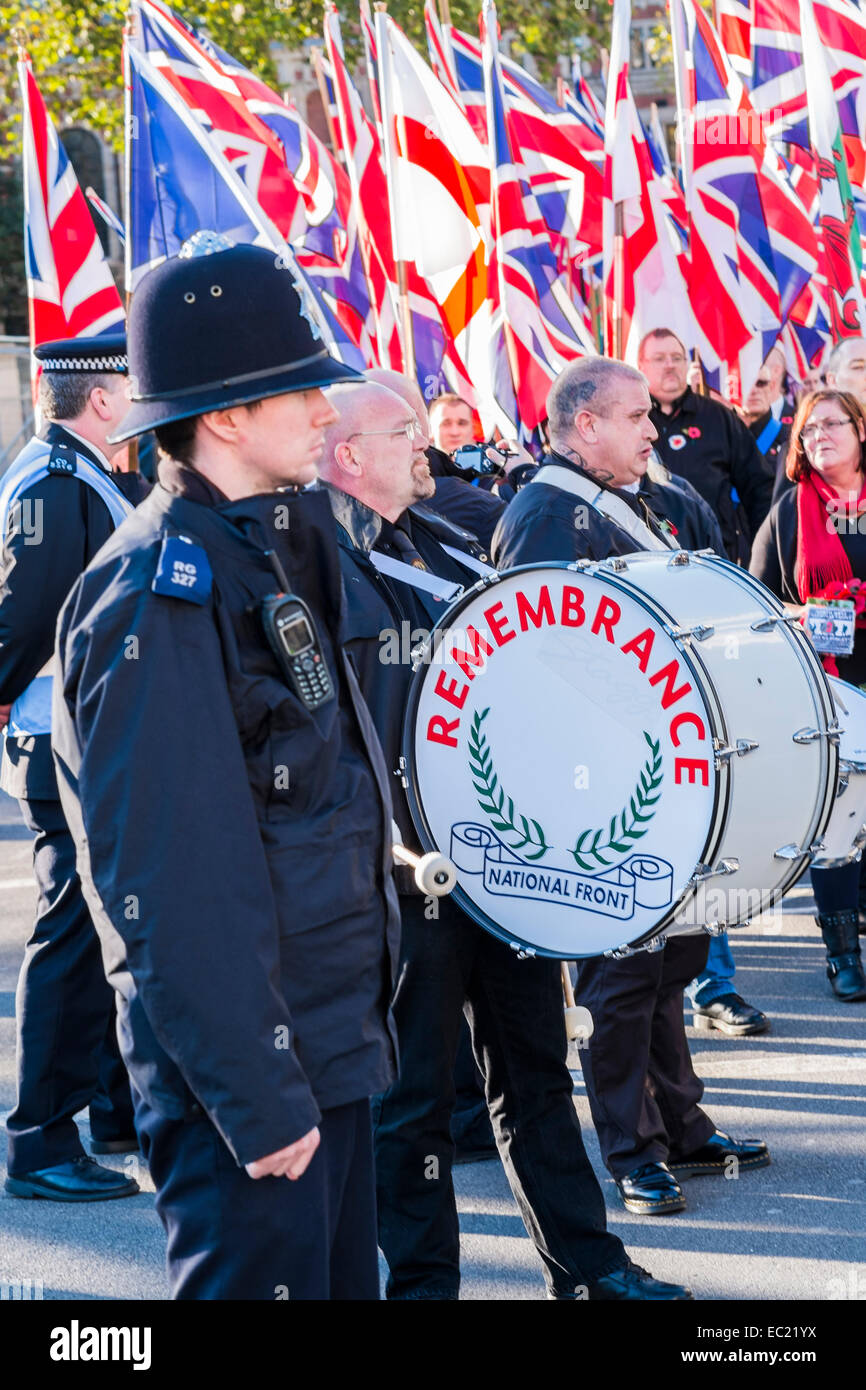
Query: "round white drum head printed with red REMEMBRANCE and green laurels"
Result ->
[[405, 566, 721, 959]]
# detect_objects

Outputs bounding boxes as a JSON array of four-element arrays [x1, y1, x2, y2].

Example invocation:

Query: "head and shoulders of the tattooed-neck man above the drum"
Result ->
[[492, 357, 676, 570]]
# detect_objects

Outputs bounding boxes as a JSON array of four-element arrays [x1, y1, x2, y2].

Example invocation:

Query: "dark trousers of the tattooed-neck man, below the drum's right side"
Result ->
[[574, 934, 716, 1177]]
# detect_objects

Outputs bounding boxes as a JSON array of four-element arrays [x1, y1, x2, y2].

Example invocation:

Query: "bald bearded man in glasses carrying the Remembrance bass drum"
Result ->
[[320, 385, 689, 1300]]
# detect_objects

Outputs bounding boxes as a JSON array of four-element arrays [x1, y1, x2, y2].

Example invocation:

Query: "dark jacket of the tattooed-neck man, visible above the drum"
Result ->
[[491, 450, 675, 570]]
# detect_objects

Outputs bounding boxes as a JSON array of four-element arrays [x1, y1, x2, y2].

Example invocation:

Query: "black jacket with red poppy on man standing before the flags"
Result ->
[[649, 386, 773, 564]]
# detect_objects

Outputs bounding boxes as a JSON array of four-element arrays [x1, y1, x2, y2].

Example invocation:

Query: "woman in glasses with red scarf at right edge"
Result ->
[[749, 391, 866, 1002]]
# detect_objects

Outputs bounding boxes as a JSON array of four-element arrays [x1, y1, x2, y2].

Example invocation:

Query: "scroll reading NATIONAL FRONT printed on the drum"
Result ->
[[450, 820, 674, 922]]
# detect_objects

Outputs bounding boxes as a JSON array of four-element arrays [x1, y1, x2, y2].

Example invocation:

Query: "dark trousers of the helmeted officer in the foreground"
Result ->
[[136, 1098, 379, 1302]]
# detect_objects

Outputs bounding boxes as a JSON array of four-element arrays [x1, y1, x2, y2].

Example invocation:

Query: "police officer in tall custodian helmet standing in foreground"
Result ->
[[54, 234, 399, 1301]]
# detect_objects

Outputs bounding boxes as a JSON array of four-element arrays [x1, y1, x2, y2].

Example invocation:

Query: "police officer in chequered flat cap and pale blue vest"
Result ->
[[0, 334, 147, 1202]]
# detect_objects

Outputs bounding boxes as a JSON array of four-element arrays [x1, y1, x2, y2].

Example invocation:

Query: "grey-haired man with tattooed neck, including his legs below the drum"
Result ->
[[493, 357, 770, 1215]]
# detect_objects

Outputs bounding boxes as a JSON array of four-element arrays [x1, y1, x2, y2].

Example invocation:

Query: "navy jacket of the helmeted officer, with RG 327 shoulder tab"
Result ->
[[53, 463, 399, 1165]]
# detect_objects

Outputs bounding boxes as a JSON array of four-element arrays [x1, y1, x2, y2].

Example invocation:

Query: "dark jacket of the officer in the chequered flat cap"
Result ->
[[0, 423, 150, 801]]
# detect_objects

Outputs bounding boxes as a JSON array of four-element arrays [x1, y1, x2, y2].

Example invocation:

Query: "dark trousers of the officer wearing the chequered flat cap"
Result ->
[[7, 801, 135, 1177]]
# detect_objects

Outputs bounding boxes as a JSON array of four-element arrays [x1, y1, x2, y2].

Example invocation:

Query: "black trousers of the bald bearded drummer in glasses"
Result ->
[[374, 897, 627, 1298]]
